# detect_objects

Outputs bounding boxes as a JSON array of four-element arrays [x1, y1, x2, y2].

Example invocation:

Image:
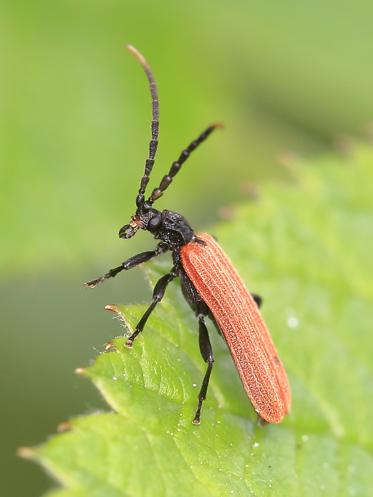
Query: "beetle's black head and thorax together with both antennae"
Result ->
[[119, 45, 221, 245]]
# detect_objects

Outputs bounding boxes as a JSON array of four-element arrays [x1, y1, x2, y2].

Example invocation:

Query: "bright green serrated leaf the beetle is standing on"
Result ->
[[24, 142, 373, 497]]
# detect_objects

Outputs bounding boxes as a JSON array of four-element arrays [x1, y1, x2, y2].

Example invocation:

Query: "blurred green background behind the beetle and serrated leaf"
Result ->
[[0, 0, 373, 497]]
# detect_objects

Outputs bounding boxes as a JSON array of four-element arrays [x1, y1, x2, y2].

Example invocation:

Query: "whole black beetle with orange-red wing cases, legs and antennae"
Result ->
[[85, 45, 291, 424]]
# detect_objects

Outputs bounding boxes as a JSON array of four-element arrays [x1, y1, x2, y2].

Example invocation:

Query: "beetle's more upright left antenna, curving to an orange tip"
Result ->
[[127, 45, 159, 207]]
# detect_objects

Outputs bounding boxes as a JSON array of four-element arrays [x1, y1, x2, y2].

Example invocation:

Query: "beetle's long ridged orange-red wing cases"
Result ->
[[180, 233, 291, 423]]
